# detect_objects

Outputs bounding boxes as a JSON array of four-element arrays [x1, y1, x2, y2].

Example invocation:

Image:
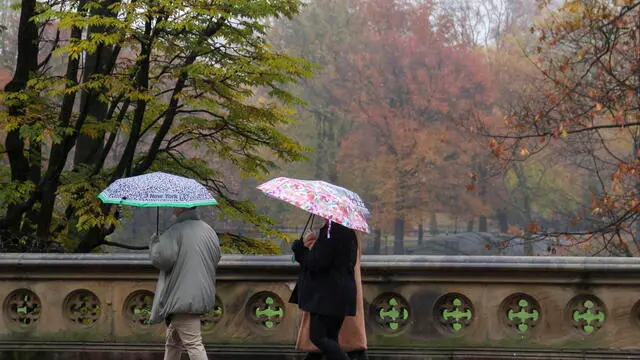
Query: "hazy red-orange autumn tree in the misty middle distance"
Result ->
[[316, 0, 492, 250]]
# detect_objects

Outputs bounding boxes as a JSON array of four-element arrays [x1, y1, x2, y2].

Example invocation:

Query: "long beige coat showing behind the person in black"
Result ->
[[296, 239, 367, 352]]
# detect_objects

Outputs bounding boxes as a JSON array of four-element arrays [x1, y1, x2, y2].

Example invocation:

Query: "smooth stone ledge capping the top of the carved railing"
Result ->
[[0, 254, 640, 285]]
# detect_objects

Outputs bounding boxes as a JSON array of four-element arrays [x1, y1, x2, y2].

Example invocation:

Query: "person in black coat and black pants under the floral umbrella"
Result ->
[[290, 222, 358, 360]]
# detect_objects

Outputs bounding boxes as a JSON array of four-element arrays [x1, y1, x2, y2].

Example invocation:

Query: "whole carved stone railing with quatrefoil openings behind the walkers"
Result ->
[[0, 254, 640, 360]]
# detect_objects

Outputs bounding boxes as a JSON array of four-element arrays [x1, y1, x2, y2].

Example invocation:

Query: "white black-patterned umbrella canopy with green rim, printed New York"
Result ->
[[98, 172, 218, 208]]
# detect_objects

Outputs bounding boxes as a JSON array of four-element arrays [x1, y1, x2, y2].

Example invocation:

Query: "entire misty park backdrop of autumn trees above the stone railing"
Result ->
[[0, 0, 640, 256]]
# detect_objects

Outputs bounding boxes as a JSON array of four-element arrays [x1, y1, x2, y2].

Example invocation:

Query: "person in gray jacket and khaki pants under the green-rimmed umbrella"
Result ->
[[149, 208, 220, 360]]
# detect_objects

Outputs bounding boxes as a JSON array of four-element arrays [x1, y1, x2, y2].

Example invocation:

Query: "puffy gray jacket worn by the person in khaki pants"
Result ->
[[149, 209, 221, 324]]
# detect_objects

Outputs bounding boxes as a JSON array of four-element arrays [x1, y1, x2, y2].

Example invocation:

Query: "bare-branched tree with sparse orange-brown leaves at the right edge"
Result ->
[[476, 0, 640, 255]]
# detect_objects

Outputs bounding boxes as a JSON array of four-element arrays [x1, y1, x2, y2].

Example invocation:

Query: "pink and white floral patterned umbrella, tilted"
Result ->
[[258, 177, 371, 233]]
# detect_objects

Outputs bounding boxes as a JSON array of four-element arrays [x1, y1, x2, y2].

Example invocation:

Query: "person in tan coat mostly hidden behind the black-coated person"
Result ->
[[296, 228, 368, 360]]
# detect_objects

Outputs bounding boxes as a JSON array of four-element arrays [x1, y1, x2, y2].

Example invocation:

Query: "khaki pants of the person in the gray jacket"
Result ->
[[164, 315, 208, 360]]
